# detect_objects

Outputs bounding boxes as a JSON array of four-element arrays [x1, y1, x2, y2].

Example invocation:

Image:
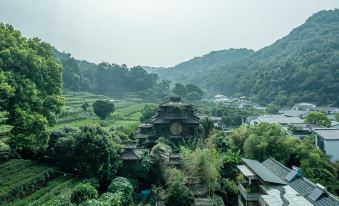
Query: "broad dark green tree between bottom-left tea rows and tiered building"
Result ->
[[50, 127, 121, 181]]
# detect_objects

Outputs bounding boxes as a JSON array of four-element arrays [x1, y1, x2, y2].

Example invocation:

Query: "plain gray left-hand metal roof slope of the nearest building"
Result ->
[[241, 158, 286, 185]]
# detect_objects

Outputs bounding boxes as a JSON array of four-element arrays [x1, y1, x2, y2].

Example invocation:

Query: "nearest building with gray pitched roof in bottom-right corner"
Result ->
[[238, 158, 339, 206]]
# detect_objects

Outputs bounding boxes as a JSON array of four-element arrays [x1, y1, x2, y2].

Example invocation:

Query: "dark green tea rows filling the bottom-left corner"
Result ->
[[0, 159, 80, 206]]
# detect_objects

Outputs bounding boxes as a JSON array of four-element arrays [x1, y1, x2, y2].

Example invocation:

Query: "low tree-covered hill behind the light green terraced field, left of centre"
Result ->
[[54, 49, 158, 94]]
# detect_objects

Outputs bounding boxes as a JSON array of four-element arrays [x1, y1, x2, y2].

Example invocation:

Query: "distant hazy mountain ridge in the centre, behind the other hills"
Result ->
[[143, 49, 254, 83]]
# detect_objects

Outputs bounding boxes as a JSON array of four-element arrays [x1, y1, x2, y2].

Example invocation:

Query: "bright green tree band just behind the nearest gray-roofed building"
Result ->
[[229, 123, 339, 194]]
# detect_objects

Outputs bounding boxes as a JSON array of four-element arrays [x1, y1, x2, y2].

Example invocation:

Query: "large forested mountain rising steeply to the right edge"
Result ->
[[150, 9, 339, 106]]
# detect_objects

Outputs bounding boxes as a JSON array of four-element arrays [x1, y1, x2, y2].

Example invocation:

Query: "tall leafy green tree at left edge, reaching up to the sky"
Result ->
[[0, 23, 63, 156]]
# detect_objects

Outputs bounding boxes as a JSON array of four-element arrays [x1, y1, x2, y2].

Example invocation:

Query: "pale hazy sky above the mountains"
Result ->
[[0, 0, 339, 66]]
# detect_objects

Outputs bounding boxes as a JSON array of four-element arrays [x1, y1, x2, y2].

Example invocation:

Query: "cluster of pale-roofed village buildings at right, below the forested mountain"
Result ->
[[246, 103, 339, 161]]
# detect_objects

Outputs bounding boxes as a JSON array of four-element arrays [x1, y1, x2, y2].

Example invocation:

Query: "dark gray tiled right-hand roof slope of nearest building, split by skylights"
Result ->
[[262, 158, 339, 206]]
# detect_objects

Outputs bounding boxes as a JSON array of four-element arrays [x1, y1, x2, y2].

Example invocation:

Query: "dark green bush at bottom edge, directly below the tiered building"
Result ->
[[165, 181, 194, 206]]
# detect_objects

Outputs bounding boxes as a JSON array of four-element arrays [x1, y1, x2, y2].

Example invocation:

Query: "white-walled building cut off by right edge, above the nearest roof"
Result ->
[[313, 128, 339, 161]]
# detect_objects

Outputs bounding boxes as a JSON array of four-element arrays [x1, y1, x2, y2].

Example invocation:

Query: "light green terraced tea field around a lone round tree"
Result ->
[[51, 92, 155, 129]]
